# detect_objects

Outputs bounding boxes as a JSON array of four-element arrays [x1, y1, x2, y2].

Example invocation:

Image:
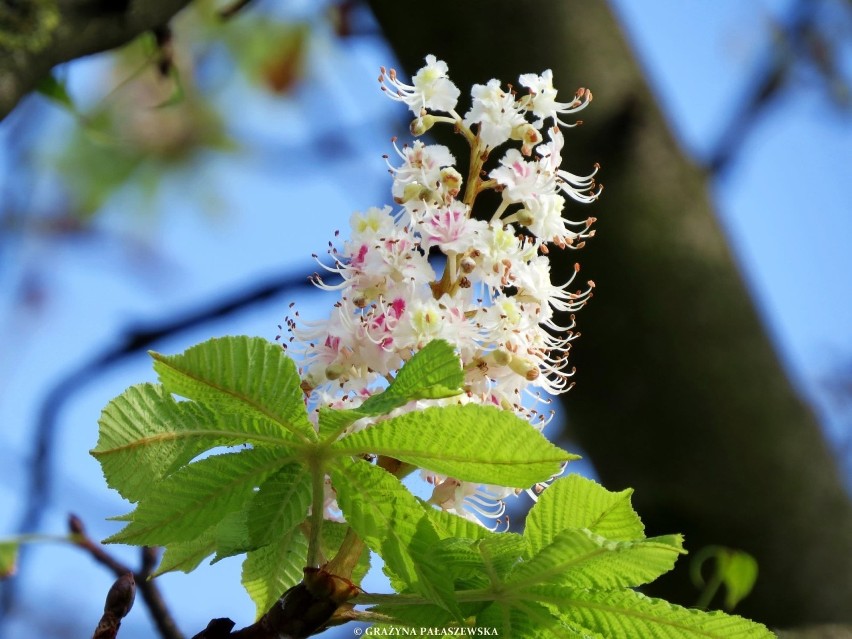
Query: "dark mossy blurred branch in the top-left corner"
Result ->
[[0, 0, 190, 120]]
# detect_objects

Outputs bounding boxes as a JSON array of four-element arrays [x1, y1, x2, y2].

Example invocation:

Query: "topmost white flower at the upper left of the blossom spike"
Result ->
[[379, 55, 460, 116]]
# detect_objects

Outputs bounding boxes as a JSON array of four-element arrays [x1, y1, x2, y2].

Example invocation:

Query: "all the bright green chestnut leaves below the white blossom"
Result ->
[[93, 337, 772, 639]]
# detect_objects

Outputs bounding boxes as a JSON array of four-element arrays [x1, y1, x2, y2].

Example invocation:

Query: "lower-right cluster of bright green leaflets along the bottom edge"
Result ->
[[375, 476, 773, 639]]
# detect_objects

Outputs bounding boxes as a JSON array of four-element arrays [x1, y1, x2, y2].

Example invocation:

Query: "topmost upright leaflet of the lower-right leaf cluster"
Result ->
[[524, 475, 645, 555]]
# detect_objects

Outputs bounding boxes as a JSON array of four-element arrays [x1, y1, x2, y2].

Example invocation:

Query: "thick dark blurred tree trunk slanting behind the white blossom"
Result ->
[[370, 0, 852, 626]]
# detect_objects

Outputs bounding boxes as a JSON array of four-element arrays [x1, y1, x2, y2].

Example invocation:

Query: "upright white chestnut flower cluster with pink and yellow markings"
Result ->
[[288, 56, 601, 517]]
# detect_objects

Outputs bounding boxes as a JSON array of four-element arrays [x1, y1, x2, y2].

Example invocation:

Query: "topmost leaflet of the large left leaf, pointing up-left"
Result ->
[[151, 336, 317, 441]]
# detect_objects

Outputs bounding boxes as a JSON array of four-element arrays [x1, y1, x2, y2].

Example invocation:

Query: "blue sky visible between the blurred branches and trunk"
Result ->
[[0, 0, 852, 639]]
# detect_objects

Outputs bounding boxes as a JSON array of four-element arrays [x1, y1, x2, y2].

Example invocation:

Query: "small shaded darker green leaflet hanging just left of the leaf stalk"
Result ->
[[248, 464, 311, 546]]
